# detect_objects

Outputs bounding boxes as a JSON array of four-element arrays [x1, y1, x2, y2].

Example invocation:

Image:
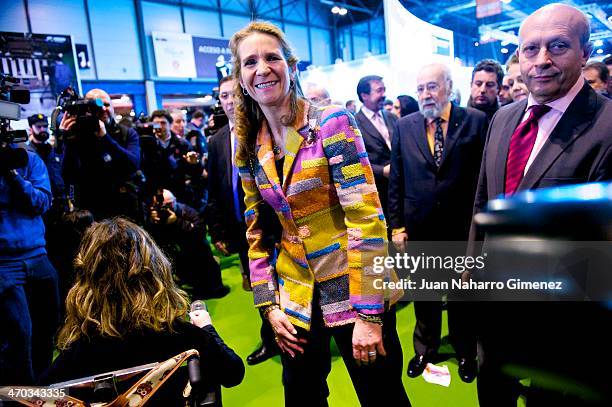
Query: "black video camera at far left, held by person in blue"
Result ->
[[0, 73, 30, 173]]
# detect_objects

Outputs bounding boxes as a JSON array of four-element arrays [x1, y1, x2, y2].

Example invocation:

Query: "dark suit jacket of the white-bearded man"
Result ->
[[389, 105, 487, 240]]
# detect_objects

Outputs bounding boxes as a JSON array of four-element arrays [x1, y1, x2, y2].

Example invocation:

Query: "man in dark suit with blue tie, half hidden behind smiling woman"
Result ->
[[206, 76, 278, 365]]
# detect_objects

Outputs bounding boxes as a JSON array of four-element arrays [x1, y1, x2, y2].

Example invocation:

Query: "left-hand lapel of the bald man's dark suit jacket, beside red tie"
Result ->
[[490, 100, 527, 195]]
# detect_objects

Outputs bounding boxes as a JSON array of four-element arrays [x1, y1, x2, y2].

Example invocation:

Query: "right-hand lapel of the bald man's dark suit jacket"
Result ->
[[518, 84, 597, 190]]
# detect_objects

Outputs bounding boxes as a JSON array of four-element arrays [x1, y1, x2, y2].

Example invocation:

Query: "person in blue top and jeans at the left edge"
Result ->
[[0, 140, 59, 385]]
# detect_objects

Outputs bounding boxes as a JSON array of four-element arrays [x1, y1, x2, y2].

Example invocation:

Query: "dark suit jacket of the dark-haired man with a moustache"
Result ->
[[355, 109, 397, 218]]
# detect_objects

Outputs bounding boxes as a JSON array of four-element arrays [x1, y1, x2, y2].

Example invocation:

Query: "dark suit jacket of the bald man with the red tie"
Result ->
[[470, 82, 612, 240]]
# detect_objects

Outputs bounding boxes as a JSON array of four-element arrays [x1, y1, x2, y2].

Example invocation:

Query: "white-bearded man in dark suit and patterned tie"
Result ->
[[389, 64, 487, 382]]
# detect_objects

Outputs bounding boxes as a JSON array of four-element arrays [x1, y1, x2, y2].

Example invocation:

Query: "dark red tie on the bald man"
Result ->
[[505, 105, 550, 195]]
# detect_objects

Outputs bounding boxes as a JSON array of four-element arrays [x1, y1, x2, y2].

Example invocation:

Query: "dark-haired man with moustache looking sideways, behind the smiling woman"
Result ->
[[355, 75, 397, 219]]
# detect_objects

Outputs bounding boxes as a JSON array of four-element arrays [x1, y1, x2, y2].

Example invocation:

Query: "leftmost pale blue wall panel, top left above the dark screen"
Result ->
[[28, 0, 96, 79]]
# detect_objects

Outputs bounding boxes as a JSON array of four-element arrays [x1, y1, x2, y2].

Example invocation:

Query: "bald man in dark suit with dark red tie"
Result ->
[[470, 4, 612, 407]]
